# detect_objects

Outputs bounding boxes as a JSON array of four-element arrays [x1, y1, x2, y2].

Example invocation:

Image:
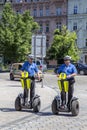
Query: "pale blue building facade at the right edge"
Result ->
[[68, 0, 87, 64]]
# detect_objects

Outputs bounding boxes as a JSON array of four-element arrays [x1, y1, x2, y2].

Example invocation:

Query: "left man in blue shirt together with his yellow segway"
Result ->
[[15, 55, 41, 112]]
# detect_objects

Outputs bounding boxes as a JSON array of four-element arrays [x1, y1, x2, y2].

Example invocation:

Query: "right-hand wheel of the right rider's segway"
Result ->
[[71, 100, 79, 116]]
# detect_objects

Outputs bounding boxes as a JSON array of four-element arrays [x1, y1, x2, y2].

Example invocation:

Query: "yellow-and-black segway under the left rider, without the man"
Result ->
[[15, 72, 41, 112]]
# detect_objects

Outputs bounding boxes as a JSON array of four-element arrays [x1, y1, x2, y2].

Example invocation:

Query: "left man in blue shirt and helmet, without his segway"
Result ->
[[21, 55, 40, 108]]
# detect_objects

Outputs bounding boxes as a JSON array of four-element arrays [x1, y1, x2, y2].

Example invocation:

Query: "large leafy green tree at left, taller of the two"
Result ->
[[0, 3, 39, 62]]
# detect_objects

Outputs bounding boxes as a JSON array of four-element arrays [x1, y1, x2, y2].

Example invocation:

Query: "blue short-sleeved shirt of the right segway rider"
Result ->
[[57, 63, 77, 79]]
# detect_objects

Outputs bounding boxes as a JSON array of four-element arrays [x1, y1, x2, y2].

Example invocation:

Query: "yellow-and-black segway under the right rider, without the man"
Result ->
[[51, 73, 79, 116]]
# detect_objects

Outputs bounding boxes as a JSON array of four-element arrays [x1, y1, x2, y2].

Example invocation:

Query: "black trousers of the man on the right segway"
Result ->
[[61, 81, 74, 105]]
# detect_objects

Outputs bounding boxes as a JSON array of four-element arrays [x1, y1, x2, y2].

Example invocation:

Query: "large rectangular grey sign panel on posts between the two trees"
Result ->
[[32, 35, 46, 57]]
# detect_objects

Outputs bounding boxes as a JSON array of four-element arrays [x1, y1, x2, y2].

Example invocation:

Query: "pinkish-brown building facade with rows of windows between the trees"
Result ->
[[11, 0, 67, 48]]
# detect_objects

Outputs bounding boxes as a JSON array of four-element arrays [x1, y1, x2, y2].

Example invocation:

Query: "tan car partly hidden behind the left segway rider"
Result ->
[[10, 63, 43, 81]]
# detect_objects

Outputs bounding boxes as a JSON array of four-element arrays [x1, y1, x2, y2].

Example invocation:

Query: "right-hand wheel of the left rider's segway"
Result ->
[[33, 97, 41, 112]]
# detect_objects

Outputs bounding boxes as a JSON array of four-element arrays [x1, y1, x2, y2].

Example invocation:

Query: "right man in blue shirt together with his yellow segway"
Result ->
[[52, 56, 79, 116]]
